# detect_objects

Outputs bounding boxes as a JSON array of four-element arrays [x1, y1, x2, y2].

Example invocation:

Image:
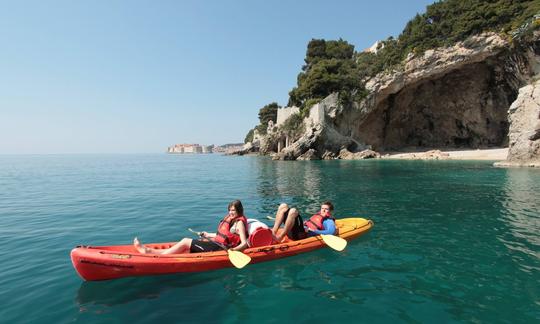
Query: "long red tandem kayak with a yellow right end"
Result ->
[[71, 218, 373, 281]]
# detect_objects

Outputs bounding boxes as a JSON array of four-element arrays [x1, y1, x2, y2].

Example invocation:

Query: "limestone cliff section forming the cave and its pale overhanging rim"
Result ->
[[352, 33, 538, 151]]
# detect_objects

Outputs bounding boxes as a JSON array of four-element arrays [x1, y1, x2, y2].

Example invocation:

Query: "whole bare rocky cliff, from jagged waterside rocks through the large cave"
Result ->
[[262, 31, 540, 165]]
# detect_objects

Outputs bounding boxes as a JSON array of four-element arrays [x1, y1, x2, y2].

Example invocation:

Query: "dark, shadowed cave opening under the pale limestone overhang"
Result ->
[[359, 62, 518, 151]]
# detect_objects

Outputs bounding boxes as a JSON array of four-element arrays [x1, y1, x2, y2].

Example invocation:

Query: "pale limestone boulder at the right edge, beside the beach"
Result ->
[[496, 80, 540, 167]]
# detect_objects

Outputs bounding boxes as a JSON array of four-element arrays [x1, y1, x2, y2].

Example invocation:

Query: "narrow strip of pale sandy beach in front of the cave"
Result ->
[[382, 148, 508, 161]]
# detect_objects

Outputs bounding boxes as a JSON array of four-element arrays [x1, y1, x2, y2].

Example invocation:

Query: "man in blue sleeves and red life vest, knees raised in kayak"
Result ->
[[272, 201, 336, 242]]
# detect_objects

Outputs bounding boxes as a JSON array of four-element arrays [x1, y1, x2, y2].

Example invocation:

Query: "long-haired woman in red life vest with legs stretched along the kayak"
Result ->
[[133, 200, 248, 254]]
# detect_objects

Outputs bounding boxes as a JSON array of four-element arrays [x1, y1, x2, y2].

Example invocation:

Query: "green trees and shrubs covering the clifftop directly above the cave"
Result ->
[[357, 0, 540, 76]]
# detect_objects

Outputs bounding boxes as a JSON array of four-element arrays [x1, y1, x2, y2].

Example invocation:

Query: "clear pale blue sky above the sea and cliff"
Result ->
[[0, 0, 433, 154]]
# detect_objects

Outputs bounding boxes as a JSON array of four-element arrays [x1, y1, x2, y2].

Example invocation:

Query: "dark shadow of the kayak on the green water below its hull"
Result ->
[[75, 253, 322, 310]]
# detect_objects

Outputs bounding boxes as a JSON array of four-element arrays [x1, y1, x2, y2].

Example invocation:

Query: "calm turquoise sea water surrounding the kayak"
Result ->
[[0, 154, 540, 323]]
